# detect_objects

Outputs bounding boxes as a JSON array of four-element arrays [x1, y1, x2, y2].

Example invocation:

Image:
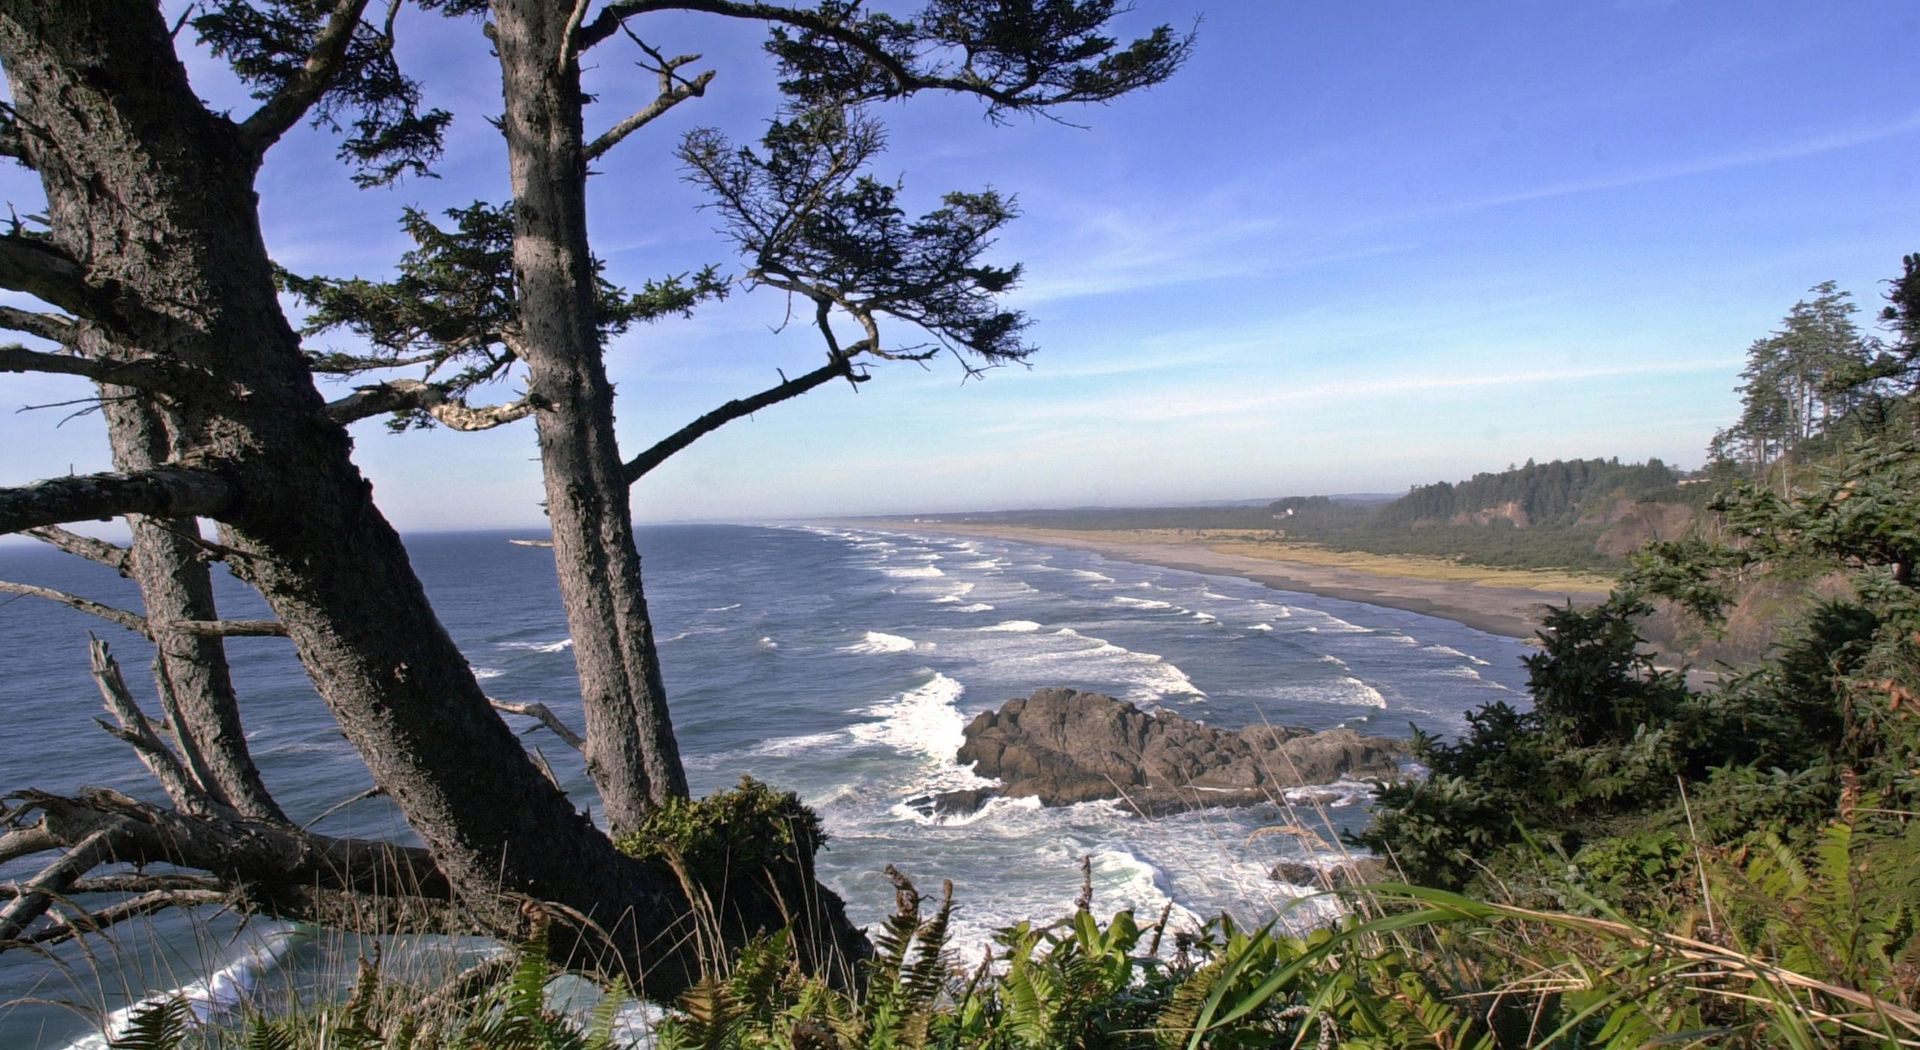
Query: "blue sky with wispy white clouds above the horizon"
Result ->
[[0, 0, 1920, 528]]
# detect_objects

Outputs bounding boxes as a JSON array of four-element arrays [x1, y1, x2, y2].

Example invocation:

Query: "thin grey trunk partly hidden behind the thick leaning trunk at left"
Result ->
[[96, 389, 286, 822]]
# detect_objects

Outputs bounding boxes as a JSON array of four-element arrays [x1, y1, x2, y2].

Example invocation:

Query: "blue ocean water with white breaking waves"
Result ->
[[0, 526, 1526, 1046]]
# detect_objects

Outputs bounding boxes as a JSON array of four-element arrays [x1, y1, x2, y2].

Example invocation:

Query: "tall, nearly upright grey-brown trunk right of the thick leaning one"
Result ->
[[493, 0, 687, 831]]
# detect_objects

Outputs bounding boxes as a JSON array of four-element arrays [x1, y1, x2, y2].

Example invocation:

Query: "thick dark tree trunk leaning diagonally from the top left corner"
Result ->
[[0, 0, 802, 992]]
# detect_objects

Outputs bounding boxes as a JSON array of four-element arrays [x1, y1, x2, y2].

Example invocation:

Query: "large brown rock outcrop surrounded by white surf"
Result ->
[[935, 689, 1405, 814]]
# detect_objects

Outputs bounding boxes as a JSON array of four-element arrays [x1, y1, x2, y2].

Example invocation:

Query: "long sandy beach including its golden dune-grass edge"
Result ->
[[860, 518, 1607, 637]]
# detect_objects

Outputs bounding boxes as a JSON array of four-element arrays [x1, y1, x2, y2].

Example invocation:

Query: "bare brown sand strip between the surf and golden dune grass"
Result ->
[[852, 518, 1601, 639]]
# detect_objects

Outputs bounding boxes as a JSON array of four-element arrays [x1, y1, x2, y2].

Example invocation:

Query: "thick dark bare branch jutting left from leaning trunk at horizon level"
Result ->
[[0, 466, 240, 536]]
